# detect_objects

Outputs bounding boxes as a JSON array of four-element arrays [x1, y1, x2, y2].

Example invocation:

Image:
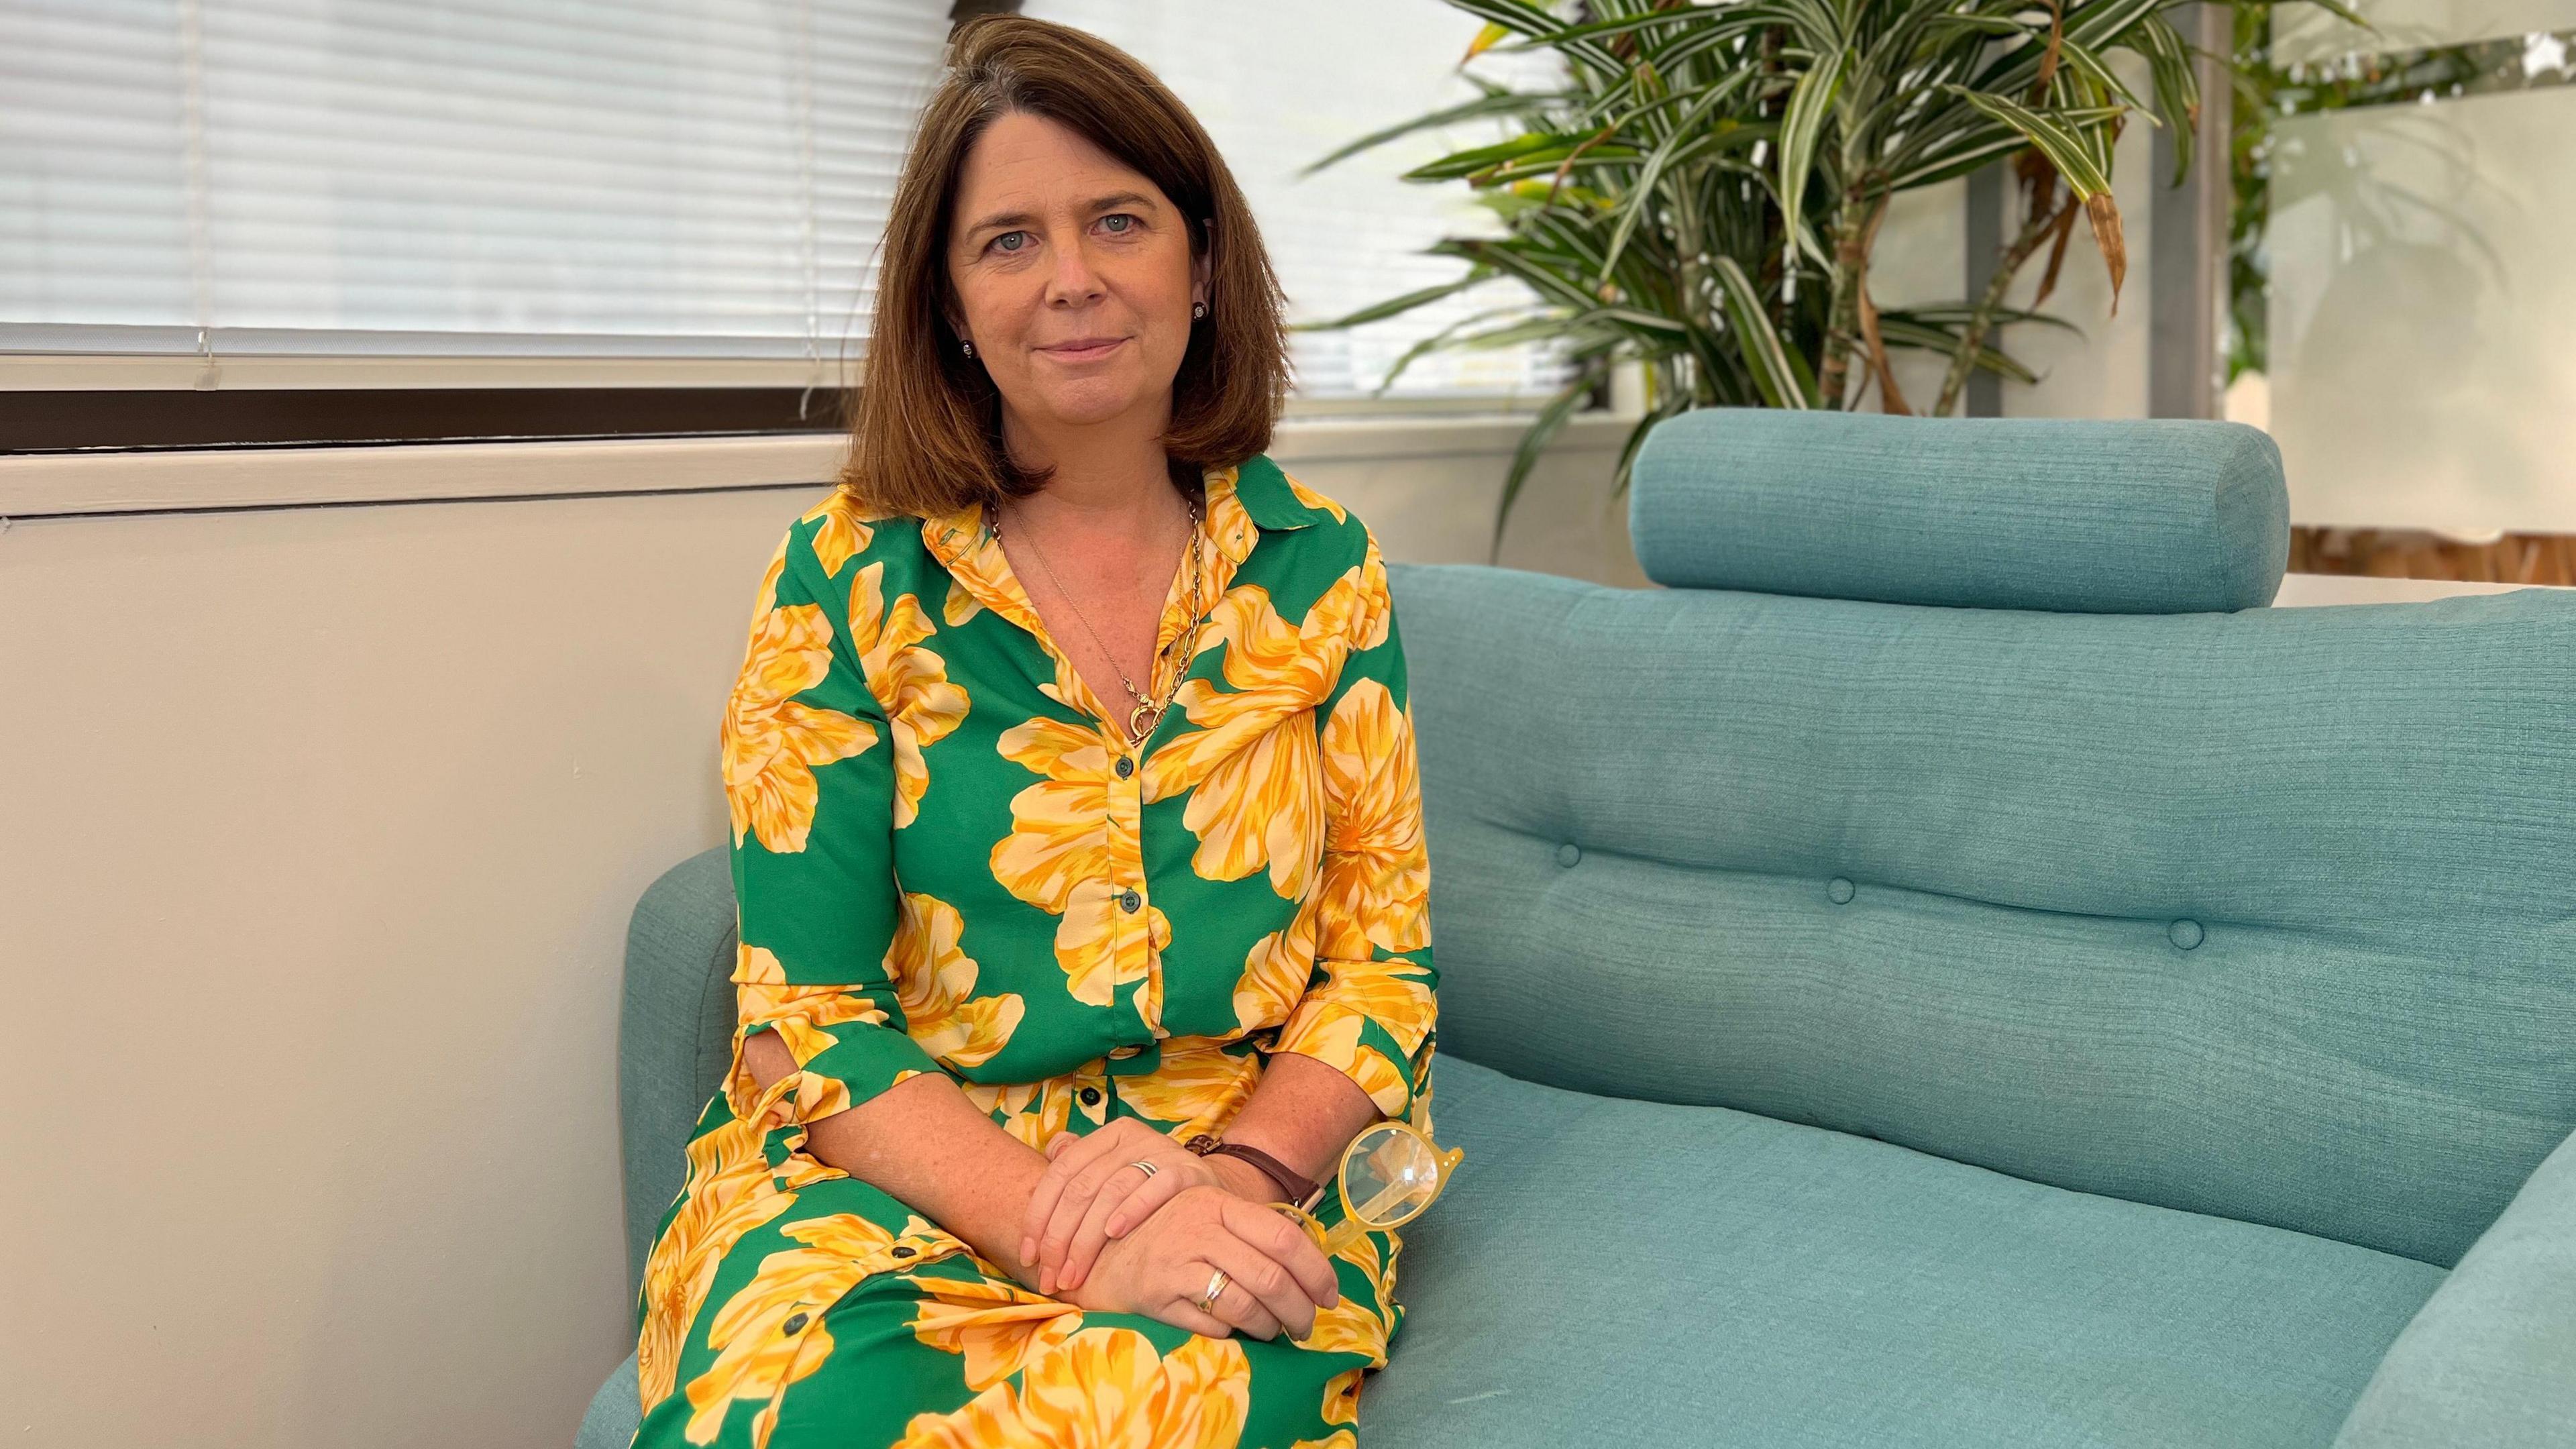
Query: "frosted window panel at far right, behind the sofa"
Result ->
[[2229, 0, 2576, 583]]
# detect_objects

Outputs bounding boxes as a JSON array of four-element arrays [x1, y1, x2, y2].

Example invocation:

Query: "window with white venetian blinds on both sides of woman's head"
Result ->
[[0, 0, 1564, 451]]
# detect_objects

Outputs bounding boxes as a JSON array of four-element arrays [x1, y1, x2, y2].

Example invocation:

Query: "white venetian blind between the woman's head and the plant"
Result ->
[[1020, 0, 1566, 397]]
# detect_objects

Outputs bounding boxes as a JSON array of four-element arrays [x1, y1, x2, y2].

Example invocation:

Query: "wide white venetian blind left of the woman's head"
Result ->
[[0, 0, 951, 364]]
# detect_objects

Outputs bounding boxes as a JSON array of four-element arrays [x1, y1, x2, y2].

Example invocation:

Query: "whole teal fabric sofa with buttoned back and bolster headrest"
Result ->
[[580, 410, 2576, 1449]]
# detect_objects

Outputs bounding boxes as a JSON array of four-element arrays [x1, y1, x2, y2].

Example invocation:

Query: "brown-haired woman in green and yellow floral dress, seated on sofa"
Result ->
[[621, 15, 1438, 1449]]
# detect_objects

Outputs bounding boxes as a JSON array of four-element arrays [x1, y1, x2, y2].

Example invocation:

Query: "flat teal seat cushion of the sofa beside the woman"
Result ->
[[1360, 1055, 2445, 1449]]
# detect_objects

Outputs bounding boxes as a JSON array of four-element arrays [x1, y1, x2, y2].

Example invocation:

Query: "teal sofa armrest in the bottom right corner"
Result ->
[[2334, 1137, 2576, 1449]]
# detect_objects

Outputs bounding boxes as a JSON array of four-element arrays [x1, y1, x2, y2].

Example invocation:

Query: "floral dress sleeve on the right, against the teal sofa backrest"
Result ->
[[1275, 523, 1440, 1116]]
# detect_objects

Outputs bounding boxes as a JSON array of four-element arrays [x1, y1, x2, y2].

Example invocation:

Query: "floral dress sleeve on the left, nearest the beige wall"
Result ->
[[724, 511, 938, 1122]]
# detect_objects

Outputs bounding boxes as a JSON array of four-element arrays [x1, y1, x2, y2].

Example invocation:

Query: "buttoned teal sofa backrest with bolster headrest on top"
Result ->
[[1391, 413, 2576, 1266]]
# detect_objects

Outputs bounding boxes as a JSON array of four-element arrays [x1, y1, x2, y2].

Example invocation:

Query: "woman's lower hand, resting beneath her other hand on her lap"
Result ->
[[1056, 1186, 1342, 1338]]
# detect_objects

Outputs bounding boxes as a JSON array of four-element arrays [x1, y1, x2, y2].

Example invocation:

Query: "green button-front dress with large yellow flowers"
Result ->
[[636, 456, 1438, 1449]]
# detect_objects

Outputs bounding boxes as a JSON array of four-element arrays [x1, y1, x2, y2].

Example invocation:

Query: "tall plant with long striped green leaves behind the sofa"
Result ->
[[1306, 0, 2342, 547]]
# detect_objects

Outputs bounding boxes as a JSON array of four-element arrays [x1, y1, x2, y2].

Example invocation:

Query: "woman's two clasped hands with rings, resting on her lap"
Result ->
[[1020, 1116, 1342, 1338]]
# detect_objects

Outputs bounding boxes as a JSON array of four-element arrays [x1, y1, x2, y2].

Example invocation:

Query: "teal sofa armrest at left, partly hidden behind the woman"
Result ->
[[619, 846, 734, 1294]]
